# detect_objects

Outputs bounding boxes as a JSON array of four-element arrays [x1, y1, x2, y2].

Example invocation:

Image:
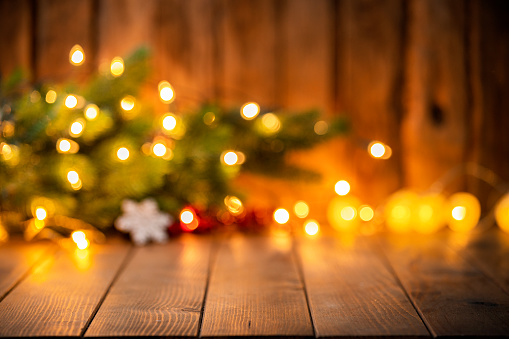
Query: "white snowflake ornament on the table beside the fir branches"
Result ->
[[115, 198, 173, 246]]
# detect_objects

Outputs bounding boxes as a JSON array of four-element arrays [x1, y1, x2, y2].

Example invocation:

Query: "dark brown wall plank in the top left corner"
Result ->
[[0, 0, 32, 78]]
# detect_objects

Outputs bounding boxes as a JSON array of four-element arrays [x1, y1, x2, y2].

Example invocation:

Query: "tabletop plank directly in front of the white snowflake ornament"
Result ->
[[86, 236, 212, 337]]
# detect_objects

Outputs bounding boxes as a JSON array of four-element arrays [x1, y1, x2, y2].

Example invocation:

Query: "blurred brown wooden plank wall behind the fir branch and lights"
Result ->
[[0, 0, 509, 214]]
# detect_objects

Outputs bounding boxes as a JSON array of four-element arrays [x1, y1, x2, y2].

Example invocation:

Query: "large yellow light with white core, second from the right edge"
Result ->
[[449, 192, 481, 232]]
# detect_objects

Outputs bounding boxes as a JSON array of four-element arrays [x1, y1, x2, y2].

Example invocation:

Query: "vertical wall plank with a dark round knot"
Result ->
[[401, 0, 469, 190]]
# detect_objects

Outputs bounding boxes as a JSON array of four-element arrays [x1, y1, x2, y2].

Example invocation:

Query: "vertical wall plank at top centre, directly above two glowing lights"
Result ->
[[217, 0, 279, 109]]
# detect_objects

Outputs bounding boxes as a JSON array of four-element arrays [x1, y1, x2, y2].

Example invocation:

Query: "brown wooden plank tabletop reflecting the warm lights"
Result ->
[[0, 230, 509, 338]]
